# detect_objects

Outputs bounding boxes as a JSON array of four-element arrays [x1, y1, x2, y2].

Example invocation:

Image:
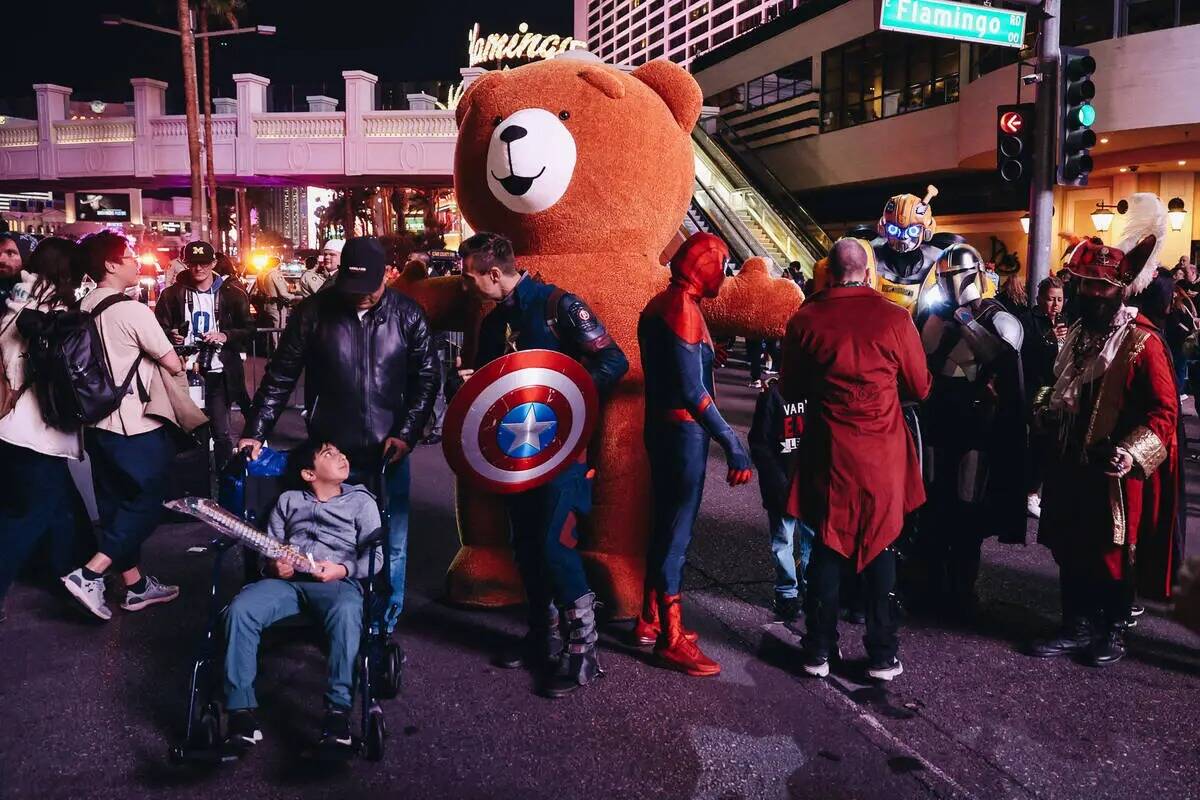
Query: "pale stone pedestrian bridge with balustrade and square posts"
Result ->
[[0, 70, 468, 191]]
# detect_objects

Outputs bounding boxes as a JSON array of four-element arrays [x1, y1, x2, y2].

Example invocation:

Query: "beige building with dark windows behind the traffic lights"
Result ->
[[690, 0, 1200, 272]]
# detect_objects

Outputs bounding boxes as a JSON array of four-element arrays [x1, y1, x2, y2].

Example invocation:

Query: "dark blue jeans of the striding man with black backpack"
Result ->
[[84, 426, 175, 572]]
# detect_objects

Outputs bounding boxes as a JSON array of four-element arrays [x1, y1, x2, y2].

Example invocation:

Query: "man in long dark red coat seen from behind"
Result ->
[[781, 239, 931, 680]]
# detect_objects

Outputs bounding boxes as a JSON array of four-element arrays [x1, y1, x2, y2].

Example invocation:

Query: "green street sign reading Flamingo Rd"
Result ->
[[880, 0, 1027, 47]]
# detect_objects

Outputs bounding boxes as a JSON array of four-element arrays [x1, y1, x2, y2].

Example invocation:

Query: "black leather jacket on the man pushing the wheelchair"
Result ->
[[244, 289, 437, 468]]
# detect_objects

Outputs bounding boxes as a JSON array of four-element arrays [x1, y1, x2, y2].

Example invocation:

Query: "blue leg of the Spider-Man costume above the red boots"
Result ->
[[646, 422, 709, 595]]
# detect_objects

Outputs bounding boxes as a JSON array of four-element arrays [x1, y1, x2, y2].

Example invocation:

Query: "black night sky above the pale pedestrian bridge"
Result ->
[[0, 0, 572, 113]]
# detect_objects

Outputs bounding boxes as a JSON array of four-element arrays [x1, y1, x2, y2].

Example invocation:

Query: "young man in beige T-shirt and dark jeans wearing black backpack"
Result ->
[[57, 231, 184, 620]]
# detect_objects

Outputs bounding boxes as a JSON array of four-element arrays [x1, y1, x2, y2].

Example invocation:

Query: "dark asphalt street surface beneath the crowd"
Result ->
[[0, 359, 1200, 800]]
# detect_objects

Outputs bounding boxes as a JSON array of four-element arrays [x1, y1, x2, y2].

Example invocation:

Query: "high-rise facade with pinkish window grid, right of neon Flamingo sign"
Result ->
[[575, 0, 822, 67]]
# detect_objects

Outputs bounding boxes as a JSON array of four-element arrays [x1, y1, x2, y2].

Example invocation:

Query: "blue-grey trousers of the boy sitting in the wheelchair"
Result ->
[[224, 578, 362, 711]]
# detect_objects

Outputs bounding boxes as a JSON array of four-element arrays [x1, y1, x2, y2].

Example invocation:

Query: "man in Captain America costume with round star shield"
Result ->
[[445, 233, 629, 697]]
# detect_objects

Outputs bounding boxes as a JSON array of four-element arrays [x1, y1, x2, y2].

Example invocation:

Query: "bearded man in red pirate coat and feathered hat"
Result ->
[[1031, 236, 1178, 667]]
